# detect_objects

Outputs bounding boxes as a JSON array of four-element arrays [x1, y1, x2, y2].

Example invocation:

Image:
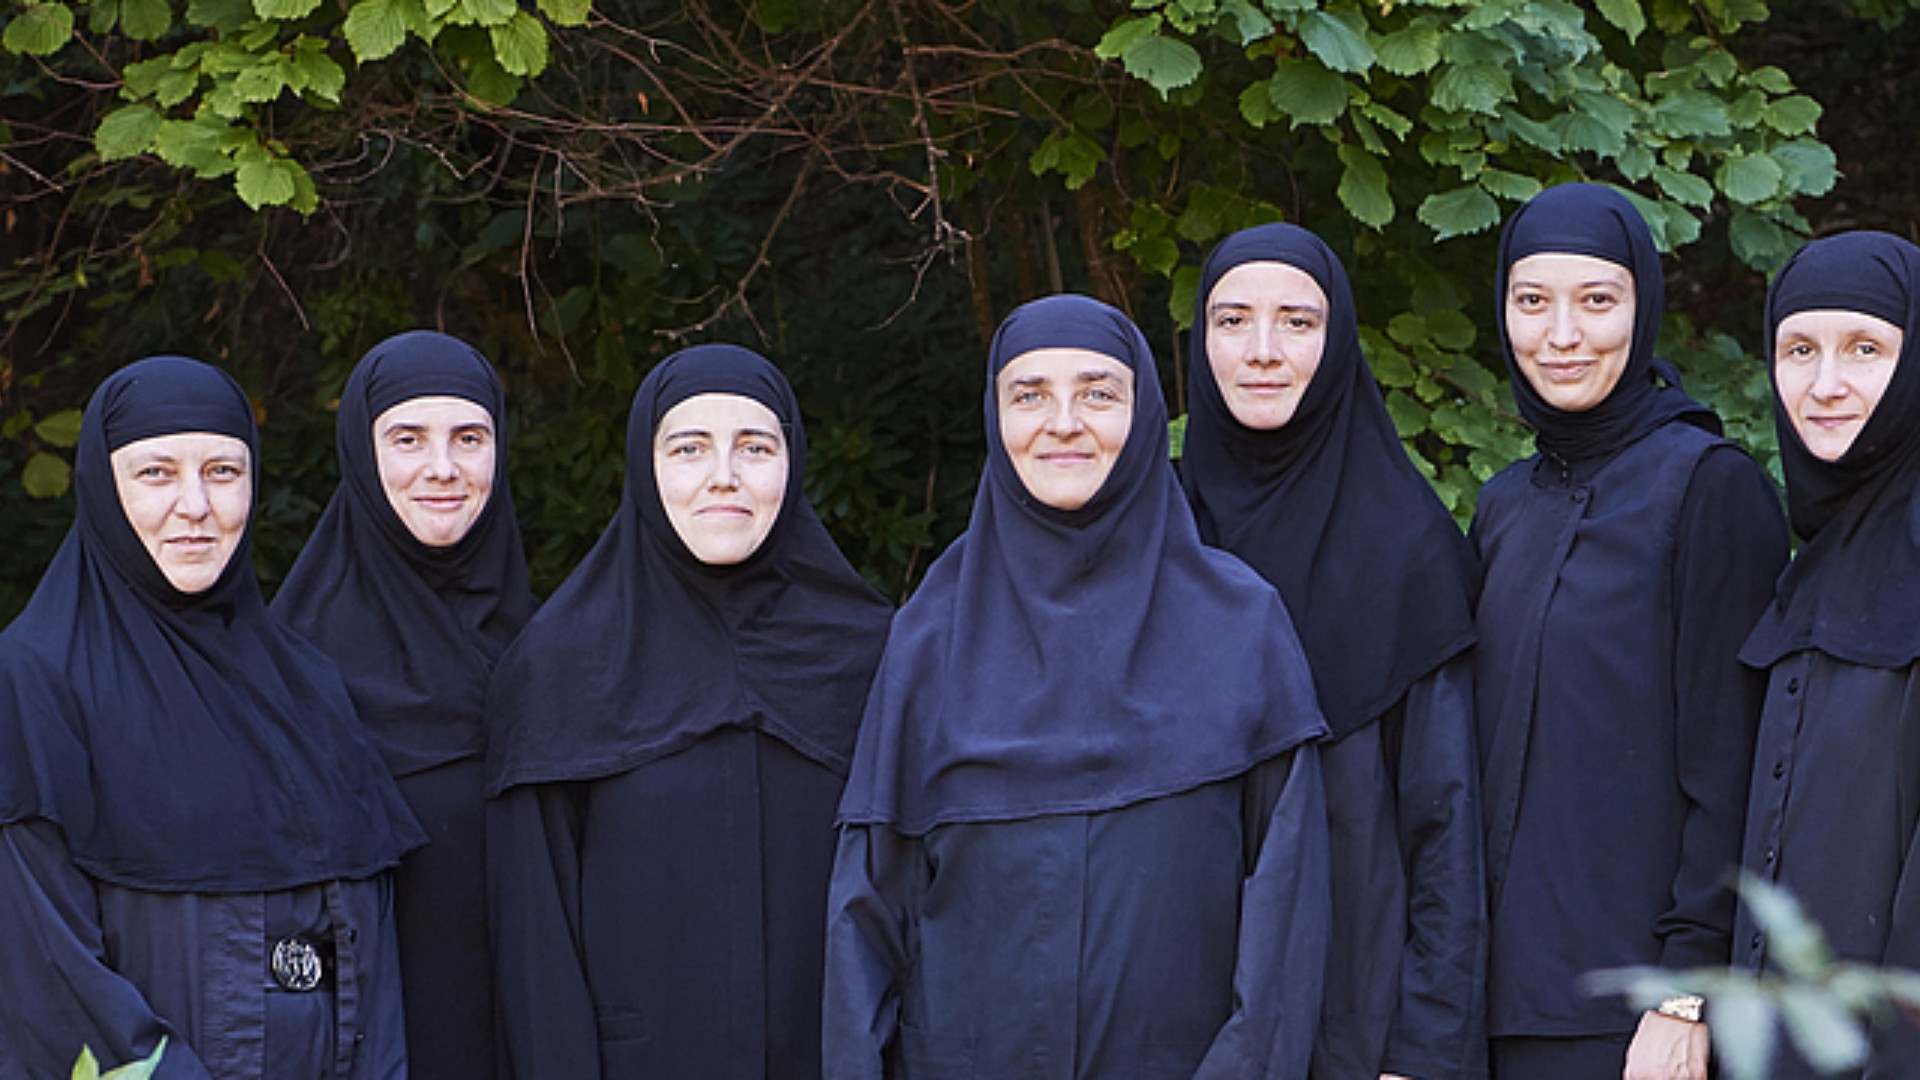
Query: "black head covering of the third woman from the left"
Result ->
[[488, 346, 889, 794]]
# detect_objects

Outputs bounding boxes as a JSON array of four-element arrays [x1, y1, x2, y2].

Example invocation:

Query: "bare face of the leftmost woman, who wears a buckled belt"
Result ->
[[108, 430, 253, 596]]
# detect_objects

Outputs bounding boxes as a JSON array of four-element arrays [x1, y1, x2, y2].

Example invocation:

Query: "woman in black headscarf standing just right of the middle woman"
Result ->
[[1181, 225, 1486, 1078]]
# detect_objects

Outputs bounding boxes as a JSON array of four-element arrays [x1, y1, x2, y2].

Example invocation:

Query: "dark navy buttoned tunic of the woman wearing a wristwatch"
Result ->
[[1473, 421, 1786, 1038]]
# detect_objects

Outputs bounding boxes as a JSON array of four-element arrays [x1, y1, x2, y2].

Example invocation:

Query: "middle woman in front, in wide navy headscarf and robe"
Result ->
[[826, 296, 1329, 1080]]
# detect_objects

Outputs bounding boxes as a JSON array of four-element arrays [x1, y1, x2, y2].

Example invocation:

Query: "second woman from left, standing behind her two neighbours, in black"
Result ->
[[273, 331, 536, 1080]]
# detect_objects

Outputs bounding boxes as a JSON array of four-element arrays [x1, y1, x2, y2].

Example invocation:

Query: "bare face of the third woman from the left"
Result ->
[[653, 394, 791, 567]]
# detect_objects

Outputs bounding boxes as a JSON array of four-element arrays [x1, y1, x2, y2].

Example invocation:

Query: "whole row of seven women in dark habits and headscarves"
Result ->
[[0, 184, 1920, 1080]]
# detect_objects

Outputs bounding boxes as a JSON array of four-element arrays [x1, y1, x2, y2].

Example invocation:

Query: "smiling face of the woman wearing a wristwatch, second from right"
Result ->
[[1507, 252, 1634, 413]]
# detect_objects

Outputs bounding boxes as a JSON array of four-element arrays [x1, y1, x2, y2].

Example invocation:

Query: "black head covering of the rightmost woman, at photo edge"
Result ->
[[1740, 233, 1920, 667]]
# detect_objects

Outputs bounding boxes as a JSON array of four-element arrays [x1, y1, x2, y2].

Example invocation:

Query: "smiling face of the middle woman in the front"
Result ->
[[995, 348, 1133, 509]]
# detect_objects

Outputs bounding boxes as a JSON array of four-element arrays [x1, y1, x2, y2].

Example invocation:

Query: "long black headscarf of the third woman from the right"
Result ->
[[1181, 225, 1480, 738]]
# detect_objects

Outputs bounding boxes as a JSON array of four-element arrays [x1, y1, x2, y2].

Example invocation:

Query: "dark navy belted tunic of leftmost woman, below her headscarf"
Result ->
[[0, 821, 407, 1080]]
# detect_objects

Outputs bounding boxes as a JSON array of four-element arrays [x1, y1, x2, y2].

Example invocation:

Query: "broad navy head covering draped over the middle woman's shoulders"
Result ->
[[841, 296, 1327, 834]]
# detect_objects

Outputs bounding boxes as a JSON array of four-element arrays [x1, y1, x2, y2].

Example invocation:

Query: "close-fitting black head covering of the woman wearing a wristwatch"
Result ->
[[1494, 184, 1720, 463]]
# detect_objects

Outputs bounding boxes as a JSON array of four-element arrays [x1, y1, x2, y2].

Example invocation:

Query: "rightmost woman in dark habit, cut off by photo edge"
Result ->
[[1734, 233, 1920, 1080]]
